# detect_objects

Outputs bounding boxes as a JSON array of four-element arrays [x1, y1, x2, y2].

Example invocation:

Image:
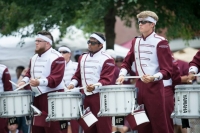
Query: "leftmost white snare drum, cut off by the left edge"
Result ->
[[0, 90, 33, 118]]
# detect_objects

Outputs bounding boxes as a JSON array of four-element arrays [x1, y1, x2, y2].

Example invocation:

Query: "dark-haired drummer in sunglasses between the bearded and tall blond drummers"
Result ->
[[68, 33, 115, 133]]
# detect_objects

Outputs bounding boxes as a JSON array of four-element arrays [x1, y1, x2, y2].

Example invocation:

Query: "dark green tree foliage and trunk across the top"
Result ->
[[0, 0, 200, 48]]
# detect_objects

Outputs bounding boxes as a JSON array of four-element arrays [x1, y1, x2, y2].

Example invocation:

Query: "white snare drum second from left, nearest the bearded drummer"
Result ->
[[46, 92, 82, 121]]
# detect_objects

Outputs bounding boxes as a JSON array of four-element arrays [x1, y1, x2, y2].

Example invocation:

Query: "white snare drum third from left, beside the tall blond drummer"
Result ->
[[98, 85, 136, 116]]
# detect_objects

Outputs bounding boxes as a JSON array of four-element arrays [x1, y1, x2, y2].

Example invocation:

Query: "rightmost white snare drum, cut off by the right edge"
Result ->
[[174, 85, 200, 118]]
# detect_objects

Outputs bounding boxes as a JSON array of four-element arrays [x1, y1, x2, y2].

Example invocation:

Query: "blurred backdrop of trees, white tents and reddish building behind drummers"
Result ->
[[0, 0, 200, 81]]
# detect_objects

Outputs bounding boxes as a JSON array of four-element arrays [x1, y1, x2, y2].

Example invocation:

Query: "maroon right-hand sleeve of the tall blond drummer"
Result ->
[[157, 40, 173, 80]]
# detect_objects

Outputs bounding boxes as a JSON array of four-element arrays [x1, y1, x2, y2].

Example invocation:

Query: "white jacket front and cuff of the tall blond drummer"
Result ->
[[133, 32, 165, 81]]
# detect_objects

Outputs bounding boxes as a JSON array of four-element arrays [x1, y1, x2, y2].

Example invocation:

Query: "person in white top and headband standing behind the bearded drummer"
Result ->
[[58, 46, 79, 133]]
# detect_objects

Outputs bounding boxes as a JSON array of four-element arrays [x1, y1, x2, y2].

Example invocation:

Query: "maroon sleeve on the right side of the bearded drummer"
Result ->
[[47, 57, 65, 88]]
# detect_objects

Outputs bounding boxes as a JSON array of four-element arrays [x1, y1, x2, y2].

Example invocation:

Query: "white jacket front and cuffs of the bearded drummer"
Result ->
[[23, 48, 65, 96]]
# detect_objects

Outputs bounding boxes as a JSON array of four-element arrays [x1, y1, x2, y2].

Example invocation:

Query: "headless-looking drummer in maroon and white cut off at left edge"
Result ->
[[0, 64, 12, 133]]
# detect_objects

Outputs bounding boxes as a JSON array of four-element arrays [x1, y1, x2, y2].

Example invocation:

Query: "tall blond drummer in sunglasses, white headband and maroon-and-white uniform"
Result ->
[[116, 11, 173, 133]]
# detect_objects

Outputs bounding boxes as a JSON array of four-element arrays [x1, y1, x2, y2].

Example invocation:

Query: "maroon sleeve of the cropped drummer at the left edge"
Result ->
[[2, 68, 12, 91]]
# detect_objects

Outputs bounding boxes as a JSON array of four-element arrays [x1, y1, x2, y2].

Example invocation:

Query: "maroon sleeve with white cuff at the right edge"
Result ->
[[189, 50, 200, 73]]
